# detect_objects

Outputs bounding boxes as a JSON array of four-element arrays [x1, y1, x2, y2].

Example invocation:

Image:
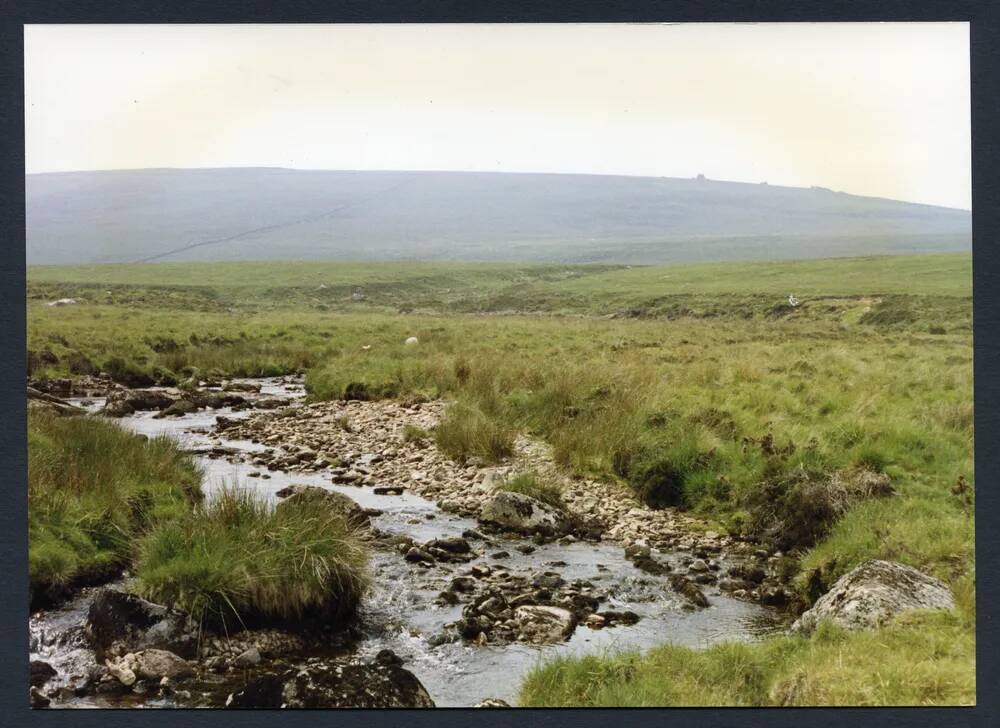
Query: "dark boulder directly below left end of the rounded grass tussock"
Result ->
[[85, 589, 198, 659]]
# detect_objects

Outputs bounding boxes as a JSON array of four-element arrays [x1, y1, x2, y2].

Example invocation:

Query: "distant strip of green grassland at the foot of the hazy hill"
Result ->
[[28, 254, 972, 314]]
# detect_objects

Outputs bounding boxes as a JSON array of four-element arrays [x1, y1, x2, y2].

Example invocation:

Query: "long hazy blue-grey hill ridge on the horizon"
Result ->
[[25, 168, 971, 264]]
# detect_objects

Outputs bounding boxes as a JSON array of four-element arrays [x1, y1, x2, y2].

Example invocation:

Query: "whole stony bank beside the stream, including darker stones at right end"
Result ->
[[219, 401, 791, 606]]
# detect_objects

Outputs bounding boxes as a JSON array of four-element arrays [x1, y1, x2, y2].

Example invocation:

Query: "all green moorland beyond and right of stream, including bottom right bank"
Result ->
[[28, 255, 975, 705]]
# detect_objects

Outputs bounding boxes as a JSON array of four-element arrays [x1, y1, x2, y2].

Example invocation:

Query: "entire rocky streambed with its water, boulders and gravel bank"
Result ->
[[30, 378, 790, 707]]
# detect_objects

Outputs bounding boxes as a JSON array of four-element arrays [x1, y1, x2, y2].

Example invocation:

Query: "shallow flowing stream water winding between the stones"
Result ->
[[30, 379, 787, 707]]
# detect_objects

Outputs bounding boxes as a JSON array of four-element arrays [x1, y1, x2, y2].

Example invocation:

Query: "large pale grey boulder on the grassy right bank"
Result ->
[[792, 561, 955, 634]]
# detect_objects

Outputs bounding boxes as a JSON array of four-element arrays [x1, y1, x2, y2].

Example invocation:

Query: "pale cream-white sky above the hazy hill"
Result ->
[[25, 23, 971, 209]]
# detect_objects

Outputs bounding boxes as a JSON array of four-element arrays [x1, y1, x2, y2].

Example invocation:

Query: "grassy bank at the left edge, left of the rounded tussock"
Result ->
[[28, 412, 201, 601]]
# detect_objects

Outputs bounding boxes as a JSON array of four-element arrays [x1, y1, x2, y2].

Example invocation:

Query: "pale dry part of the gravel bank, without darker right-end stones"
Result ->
[[221, 401, 743, 552]]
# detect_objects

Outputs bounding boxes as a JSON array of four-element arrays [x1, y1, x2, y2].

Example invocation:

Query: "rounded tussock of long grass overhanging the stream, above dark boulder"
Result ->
[[135, 488, 368, 628]]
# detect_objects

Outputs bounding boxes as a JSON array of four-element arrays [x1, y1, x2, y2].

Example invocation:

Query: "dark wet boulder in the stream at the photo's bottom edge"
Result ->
[[226, 663, 434, 708]]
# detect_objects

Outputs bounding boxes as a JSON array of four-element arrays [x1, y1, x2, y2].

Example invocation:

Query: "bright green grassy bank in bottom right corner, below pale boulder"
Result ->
[[520, 612, 975, 707]]
